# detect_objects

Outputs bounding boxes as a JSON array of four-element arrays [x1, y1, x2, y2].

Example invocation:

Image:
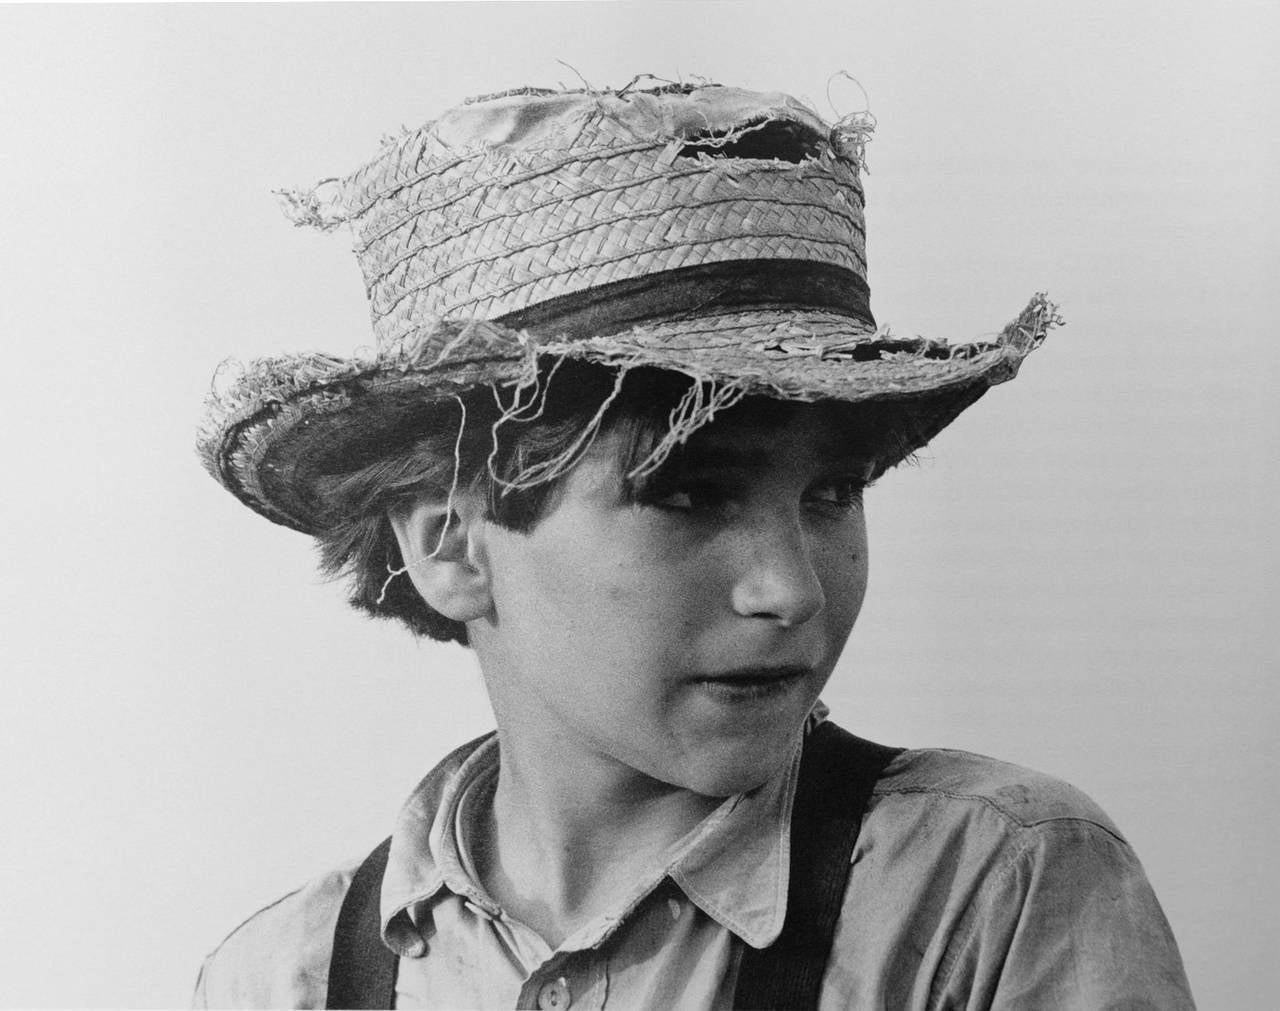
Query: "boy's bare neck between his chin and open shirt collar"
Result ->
[[471, 731, 722, 948]]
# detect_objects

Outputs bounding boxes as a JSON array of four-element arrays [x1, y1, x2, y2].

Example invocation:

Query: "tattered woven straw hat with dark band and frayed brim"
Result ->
[[198, 86, 1059, 531]]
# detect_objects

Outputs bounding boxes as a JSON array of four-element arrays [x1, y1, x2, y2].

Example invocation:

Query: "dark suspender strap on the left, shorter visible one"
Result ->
[[324, 838, 399, 1007]]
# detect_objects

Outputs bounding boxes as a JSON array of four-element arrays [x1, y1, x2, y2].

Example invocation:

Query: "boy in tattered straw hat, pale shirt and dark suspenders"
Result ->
[[196, 82, 1192, 1008]]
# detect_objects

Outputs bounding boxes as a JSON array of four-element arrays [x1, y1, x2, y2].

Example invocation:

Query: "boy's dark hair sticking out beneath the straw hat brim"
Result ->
[[307, 360, 960, 645]]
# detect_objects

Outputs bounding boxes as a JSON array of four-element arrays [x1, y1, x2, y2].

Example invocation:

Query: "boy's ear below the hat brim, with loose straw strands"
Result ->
[[387, 495, 493, 622]]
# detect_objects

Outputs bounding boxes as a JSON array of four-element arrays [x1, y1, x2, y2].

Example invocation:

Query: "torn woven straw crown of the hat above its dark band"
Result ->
[[286, 86, 870, 347]]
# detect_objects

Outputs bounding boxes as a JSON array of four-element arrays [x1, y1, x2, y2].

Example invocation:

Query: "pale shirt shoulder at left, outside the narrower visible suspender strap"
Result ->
[[186, 859, 360, 1007]]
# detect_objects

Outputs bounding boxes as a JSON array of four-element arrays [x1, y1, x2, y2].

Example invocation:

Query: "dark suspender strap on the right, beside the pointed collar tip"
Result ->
[[733, 723, 902, 1011]]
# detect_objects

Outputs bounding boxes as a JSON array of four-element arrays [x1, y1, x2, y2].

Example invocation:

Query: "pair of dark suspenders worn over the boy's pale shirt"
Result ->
[[325, 723, 901, 1011]]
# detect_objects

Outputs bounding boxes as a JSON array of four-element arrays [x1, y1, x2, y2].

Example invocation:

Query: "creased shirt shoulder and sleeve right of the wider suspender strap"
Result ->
[[826, 749, 1192, 1008]]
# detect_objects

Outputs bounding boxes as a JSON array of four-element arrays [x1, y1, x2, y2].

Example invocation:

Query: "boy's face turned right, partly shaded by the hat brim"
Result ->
[[468, 406, 869, 796]]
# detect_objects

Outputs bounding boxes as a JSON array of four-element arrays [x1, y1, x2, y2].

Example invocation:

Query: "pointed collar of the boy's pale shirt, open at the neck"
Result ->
[[381, 721, 826, 957]]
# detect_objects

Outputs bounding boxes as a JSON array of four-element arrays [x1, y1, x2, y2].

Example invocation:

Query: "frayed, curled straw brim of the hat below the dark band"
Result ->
[[197, 294, 1061, 532]]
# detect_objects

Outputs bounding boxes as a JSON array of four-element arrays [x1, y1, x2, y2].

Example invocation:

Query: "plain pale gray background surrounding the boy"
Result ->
[[0, 0, 1280, 1008]]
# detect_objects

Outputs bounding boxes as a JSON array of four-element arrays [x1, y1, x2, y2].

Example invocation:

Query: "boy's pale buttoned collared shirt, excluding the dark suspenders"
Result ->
[[195, 737, 1193, 1011]]
